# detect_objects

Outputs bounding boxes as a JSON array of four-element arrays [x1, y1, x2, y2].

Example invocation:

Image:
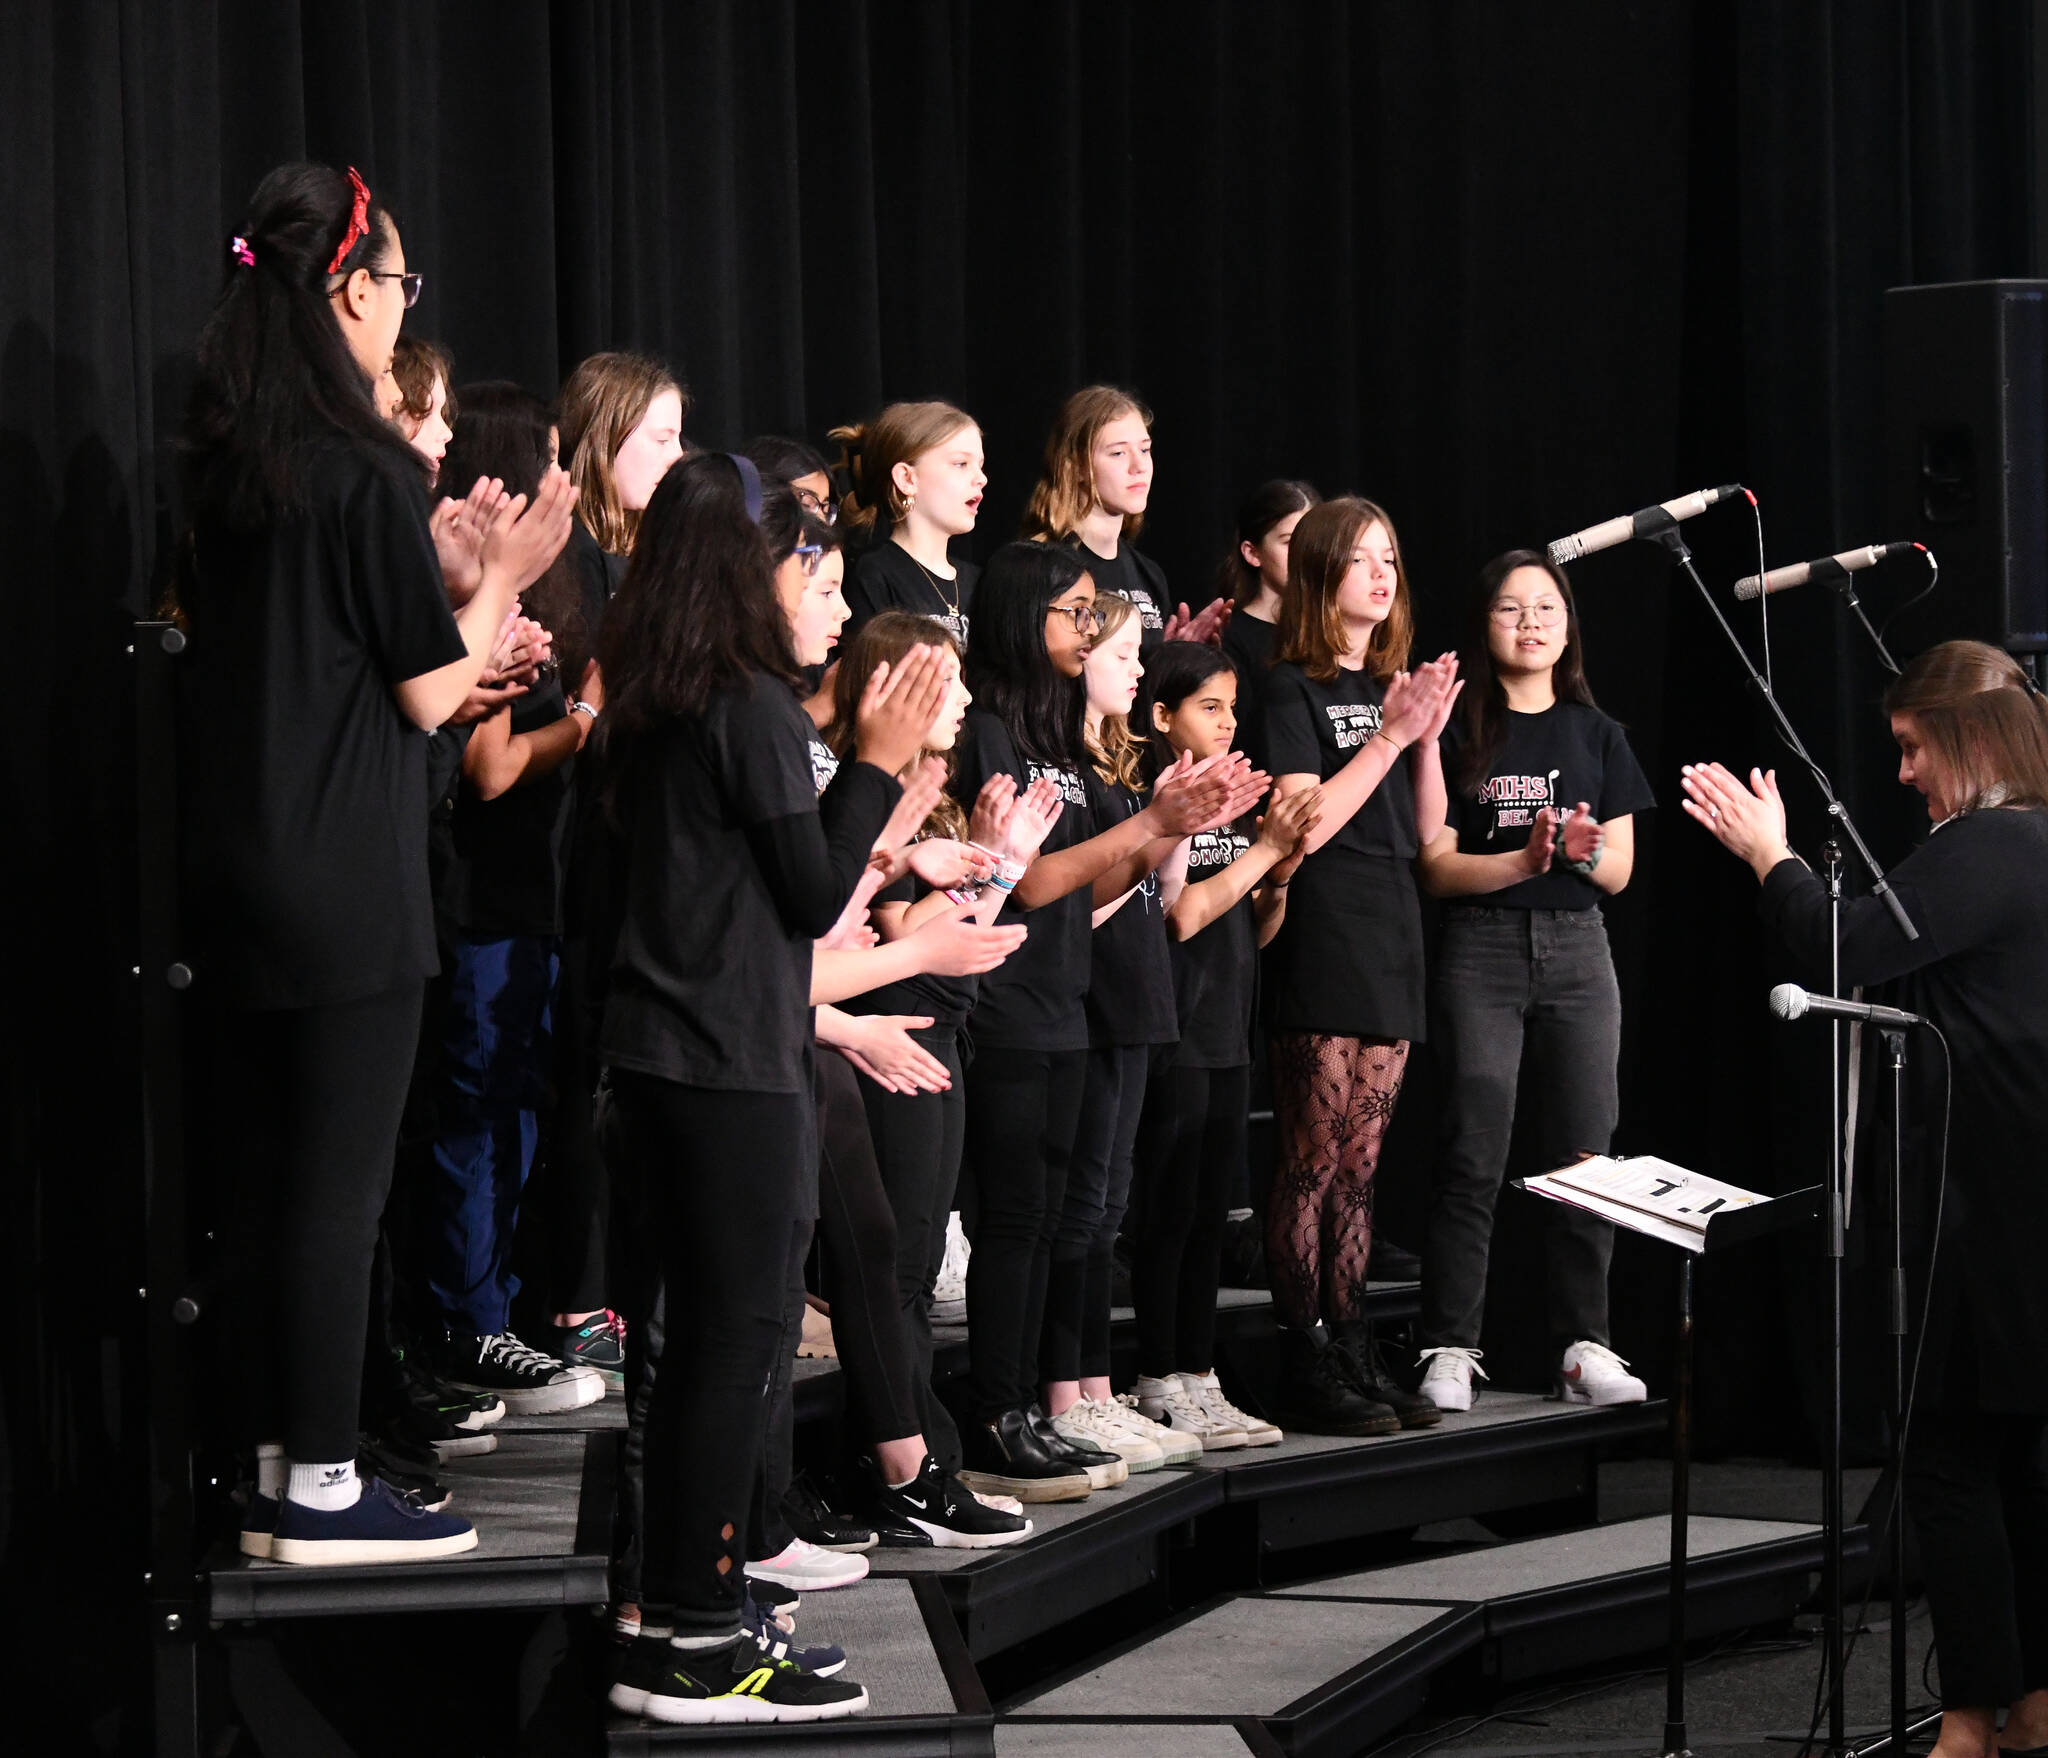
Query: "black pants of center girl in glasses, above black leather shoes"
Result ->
[[967, 1049, 1087, 1418]]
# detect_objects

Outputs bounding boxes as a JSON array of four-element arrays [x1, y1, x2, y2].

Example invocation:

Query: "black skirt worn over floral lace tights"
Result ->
[[1262, 848, 1427, 1043]]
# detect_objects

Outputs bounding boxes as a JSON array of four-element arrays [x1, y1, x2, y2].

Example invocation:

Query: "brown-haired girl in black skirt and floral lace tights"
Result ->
[[1266, 496, 1458, 1434]]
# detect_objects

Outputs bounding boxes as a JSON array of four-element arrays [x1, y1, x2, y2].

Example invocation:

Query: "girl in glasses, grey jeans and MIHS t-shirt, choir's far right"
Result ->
[[1421, 549, 1657, 1410]]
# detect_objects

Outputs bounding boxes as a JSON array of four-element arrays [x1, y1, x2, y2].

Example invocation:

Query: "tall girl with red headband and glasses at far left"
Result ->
[[178, 164, 573, 1563]]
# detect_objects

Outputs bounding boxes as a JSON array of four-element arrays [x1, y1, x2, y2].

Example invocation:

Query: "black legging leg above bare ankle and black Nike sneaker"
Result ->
[[817, 1049, 944, 1445]]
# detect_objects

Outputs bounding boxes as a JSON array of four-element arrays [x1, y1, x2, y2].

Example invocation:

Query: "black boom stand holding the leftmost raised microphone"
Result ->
[[1636, 518, 1919, 1754]]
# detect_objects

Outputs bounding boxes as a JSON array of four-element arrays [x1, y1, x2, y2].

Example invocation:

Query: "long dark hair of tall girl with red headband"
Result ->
[[182, 164, 424, 531]]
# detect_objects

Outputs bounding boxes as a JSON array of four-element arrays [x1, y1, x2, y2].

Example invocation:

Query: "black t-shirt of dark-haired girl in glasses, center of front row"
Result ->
[[952, 709, 1094, 1049]]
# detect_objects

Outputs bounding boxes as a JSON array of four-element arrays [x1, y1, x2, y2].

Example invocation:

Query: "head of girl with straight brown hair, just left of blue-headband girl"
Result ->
[[561, 352, 690, 555]]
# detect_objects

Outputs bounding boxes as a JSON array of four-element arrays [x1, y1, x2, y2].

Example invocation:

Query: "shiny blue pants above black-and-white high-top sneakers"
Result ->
[[422, 934, 561, 1336]]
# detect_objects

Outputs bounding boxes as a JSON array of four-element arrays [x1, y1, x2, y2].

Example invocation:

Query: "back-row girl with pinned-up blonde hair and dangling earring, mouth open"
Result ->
[[831, 404, 989, 647]]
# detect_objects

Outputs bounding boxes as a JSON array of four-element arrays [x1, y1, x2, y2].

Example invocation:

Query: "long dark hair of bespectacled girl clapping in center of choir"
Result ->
[[967, 543, 1087, 768]]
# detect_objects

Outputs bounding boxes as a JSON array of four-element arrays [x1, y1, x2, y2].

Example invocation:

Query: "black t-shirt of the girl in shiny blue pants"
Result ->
[[444, 674, 578, 936]]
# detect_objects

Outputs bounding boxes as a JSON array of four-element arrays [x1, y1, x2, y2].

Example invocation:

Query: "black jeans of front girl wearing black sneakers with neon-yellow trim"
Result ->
[[612, 1070, 817, 1635]]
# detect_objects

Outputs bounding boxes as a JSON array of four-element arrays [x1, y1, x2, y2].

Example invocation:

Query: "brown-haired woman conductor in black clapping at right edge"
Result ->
[[1683, 641, 2048, 1758]]
